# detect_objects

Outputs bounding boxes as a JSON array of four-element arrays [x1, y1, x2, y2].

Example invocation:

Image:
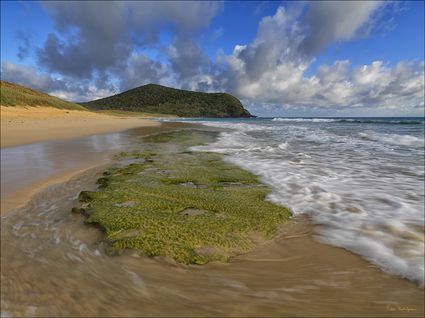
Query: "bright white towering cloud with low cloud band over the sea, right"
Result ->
[[226, 2, 424, 112]]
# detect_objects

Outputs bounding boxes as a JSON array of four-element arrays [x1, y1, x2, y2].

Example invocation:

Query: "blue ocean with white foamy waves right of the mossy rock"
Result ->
[[165, 118, 424, 287]]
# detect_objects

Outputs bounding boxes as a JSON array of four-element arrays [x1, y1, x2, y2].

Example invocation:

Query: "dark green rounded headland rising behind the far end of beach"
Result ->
[[81, 84, 251, 117]]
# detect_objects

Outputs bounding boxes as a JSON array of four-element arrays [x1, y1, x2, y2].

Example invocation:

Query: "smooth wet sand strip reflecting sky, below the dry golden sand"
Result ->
[[1, 123, 188, 212]]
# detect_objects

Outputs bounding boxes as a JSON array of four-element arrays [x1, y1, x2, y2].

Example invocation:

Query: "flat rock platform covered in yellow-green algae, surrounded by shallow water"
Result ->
[[73, 130, 290, 264]]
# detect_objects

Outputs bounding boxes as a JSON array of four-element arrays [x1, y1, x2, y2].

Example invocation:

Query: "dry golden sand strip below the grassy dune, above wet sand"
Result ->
[[1, 106, 160, 148]]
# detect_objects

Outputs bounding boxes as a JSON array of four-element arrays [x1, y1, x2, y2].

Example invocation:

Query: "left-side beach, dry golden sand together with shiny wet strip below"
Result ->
[[1, 106, 164, 213]]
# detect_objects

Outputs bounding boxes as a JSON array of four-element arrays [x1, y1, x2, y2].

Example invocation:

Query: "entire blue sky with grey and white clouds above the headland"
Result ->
[[1, 1, 424, 117]]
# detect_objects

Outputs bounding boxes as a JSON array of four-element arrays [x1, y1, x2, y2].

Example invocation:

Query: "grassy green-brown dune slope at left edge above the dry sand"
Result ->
[[0, 81, 86, 110]]
